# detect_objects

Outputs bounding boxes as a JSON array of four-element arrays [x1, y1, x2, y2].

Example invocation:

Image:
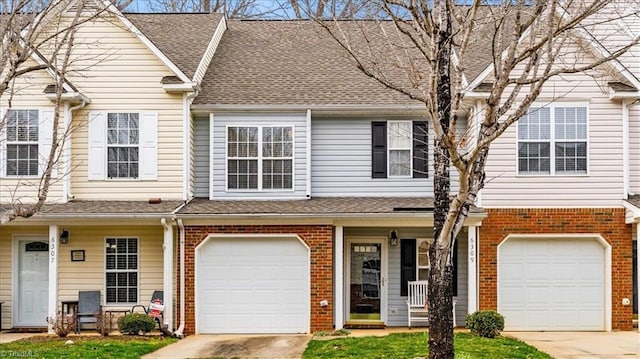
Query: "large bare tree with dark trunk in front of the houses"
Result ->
[[294, 0, 640, 358]]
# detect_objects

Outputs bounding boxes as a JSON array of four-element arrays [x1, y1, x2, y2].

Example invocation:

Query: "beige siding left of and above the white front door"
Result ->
[[0, 226, 49, 329]]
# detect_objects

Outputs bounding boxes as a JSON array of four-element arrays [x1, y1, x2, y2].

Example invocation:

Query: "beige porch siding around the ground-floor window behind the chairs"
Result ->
[[58, 225, 163, 309]]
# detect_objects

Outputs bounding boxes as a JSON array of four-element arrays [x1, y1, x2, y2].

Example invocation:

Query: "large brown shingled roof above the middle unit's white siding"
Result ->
[[194, 20, 416, 105]]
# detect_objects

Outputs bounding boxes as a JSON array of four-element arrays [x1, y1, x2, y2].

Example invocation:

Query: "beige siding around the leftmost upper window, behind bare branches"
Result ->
[[0, 60, 64, 203]]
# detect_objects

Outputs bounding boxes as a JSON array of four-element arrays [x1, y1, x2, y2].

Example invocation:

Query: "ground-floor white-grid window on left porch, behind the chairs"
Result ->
[[105, 238, 138, 303]]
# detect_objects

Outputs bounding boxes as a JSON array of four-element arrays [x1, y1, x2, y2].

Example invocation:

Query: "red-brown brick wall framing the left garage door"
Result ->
[[176, 225, 334, 334]]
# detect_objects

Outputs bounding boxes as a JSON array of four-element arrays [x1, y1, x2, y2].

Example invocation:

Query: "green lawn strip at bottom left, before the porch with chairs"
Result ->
[[0, 335, 177, 359]]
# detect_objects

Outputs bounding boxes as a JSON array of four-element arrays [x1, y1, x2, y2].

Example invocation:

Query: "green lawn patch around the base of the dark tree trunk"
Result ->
[[303, 332, 551, 359]]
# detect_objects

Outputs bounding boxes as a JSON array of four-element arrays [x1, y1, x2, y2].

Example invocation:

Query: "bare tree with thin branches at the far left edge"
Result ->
[[0, 0, 95, 225]]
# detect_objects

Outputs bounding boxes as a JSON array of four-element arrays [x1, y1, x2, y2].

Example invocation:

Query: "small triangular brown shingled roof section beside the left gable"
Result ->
[[125, 13, 223, 78]]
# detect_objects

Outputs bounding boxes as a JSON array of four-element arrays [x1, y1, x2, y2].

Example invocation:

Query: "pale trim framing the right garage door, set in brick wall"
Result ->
[[496, 233, 612, 332]]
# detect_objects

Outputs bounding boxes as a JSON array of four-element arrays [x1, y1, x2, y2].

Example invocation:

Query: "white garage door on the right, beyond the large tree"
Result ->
[[498, 238, 605, 330]]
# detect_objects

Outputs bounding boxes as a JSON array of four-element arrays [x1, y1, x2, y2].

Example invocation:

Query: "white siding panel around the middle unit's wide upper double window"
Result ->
[[211, 113, 307, 199]]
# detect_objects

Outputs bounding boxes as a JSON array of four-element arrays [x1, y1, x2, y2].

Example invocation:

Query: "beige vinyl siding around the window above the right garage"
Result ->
[[482, 69, 623, 207]]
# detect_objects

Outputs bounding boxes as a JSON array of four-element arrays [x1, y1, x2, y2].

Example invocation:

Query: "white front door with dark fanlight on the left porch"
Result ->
[[15, 239, 49, 327]]
